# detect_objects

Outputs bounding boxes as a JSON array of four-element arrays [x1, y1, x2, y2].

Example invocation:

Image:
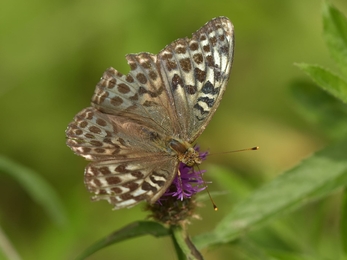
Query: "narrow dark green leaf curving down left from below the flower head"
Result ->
[[76, 221, 171, 260]]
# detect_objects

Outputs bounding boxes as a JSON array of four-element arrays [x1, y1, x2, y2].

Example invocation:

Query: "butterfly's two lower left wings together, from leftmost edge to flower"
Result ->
[[66, 107, 178, 209]]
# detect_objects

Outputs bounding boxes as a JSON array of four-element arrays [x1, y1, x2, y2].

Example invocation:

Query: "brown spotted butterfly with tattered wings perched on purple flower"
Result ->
[[66, 17, 234, 209]]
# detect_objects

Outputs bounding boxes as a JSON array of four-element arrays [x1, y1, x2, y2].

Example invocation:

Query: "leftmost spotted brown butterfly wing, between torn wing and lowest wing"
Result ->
[[66, 107, 178, 161]]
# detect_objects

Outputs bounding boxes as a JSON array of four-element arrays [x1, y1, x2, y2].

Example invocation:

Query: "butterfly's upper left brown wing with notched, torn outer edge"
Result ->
[[92, 53, 180, 136]]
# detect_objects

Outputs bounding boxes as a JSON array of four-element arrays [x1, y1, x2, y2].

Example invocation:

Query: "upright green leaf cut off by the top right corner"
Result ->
[[323, 1, 347, 76]]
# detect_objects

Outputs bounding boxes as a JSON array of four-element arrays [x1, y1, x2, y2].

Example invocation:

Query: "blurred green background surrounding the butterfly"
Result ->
[[0, 0, 347, 259]]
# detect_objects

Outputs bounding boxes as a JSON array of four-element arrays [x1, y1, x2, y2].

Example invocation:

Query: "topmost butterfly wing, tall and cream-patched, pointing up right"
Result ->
[[158, 17, 234, 143]]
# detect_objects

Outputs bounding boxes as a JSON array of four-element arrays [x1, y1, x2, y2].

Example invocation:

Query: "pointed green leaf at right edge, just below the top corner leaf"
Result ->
[[296, 63, 347, 103]]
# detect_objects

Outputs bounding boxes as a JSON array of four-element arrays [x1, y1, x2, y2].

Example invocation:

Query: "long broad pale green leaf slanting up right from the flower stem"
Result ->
[[193, 141, 347, 249]]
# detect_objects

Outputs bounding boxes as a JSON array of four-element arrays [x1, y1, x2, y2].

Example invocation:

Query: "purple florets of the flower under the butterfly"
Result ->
[[157, 146, 208, 204]]
